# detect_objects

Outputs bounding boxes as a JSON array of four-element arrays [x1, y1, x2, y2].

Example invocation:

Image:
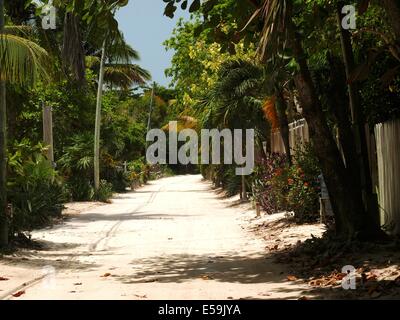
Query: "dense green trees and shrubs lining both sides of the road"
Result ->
[[0, 0, 400, 248]]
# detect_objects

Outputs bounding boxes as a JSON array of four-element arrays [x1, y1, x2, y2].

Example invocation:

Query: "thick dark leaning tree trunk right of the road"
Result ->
[[287, 2, 378, 238]]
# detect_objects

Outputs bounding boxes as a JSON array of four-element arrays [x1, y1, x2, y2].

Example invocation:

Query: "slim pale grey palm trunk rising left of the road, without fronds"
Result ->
[[94, 40, 107, 191]]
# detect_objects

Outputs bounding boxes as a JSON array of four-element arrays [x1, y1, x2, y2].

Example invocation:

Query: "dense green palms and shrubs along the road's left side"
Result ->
[[0, 0, 174, 243]]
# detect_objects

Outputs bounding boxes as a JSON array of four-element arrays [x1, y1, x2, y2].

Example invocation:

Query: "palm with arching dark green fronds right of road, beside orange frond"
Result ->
[[200, 60, 268, 200]]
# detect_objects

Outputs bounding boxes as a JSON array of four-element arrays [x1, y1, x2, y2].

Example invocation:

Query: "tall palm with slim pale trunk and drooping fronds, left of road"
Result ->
[[53, 0, 144, 191]]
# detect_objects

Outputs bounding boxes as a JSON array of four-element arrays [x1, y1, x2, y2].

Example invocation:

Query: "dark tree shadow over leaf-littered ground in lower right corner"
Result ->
[[271, 236, 400, 300]]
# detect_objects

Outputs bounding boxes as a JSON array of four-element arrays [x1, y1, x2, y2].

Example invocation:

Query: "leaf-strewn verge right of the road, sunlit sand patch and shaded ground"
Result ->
[[250, 214, 400, 300]]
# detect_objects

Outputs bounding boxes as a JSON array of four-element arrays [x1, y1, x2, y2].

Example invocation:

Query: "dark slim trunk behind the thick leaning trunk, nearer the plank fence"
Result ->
[[336, 2, 379, 226]]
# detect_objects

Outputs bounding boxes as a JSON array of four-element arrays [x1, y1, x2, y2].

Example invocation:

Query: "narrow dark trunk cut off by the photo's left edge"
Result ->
[[0, 0, 8, 247]]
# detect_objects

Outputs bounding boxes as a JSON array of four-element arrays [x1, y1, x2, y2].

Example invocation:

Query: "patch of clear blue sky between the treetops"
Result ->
[[117, 0, 189, 86]]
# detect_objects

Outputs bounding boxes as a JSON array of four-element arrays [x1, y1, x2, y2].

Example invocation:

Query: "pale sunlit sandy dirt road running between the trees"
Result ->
[[0, 175, 307, 300]]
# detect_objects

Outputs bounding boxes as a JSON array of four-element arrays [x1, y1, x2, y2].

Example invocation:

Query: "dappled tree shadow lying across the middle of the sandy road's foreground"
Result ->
[[119, 253, 292, 284]]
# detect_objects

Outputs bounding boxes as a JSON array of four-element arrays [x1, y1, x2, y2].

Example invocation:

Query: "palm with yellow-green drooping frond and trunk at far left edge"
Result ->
[[0, 0, 48, 246]]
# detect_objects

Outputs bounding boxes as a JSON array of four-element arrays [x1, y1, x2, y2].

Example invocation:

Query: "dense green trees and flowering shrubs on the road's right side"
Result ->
[[165, 0, 400, 239]]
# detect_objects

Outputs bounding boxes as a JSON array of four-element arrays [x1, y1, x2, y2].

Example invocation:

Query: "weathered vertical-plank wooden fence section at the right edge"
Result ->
[[375, 120, 400, 234]]
